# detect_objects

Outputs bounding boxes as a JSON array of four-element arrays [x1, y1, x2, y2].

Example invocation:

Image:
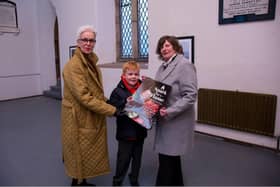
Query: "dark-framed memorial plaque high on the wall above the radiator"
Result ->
[[219, 0, 276, 24]]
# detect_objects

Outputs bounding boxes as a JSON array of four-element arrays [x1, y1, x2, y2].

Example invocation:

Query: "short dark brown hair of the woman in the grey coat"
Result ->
[[156, 35, 183, 59]]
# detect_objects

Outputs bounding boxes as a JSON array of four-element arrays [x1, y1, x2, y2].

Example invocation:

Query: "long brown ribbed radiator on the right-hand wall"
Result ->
[[197, 88, 277, 136]]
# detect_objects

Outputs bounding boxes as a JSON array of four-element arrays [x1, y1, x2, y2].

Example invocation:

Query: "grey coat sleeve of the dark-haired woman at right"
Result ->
[[166, 63, 197, 119]]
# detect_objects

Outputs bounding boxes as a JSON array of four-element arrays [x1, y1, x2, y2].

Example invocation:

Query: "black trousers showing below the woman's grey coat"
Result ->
[[156, 154, 184, 186]]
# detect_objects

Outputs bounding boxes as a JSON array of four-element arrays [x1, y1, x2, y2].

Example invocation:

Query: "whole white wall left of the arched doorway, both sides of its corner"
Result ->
[[0, 0, 56, 100]]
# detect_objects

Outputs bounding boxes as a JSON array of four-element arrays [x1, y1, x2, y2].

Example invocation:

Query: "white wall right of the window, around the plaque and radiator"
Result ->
[[149, 0, 280, 148]]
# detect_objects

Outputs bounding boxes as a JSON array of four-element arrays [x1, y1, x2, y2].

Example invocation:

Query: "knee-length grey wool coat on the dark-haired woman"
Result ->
[[154, 54, 197, 156]]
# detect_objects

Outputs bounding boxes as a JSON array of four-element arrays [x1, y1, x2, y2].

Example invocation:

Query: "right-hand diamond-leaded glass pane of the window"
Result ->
[[138, 0, 149, 58]]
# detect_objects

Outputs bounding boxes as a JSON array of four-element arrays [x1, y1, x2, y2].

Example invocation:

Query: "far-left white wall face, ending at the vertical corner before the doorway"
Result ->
[[0, 0, 41, 100]]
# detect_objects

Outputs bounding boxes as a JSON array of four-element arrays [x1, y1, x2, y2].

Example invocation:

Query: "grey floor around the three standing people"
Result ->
[[0, 96, 280, 186]]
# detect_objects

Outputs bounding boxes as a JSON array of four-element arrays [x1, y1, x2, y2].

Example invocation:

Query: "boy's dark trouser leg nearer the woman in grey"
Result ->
[[129, 141, 144, 186]]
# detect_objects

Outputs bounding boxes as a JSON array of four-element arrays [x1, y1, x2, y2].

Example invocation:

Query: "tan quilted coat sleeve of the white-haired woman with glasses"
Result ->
[[63, 60, 116, 116]]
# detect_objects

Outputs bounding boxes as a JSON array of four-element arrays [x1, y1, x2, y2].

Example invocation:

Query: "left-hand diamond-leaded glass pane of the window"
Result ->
[[120, 0, 133, 58]]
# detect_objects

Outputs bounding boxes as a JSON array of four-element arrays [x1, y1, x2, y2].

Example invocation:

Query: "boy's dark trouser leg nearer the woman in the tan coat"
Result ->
[[113, 141, 132, 186]]
